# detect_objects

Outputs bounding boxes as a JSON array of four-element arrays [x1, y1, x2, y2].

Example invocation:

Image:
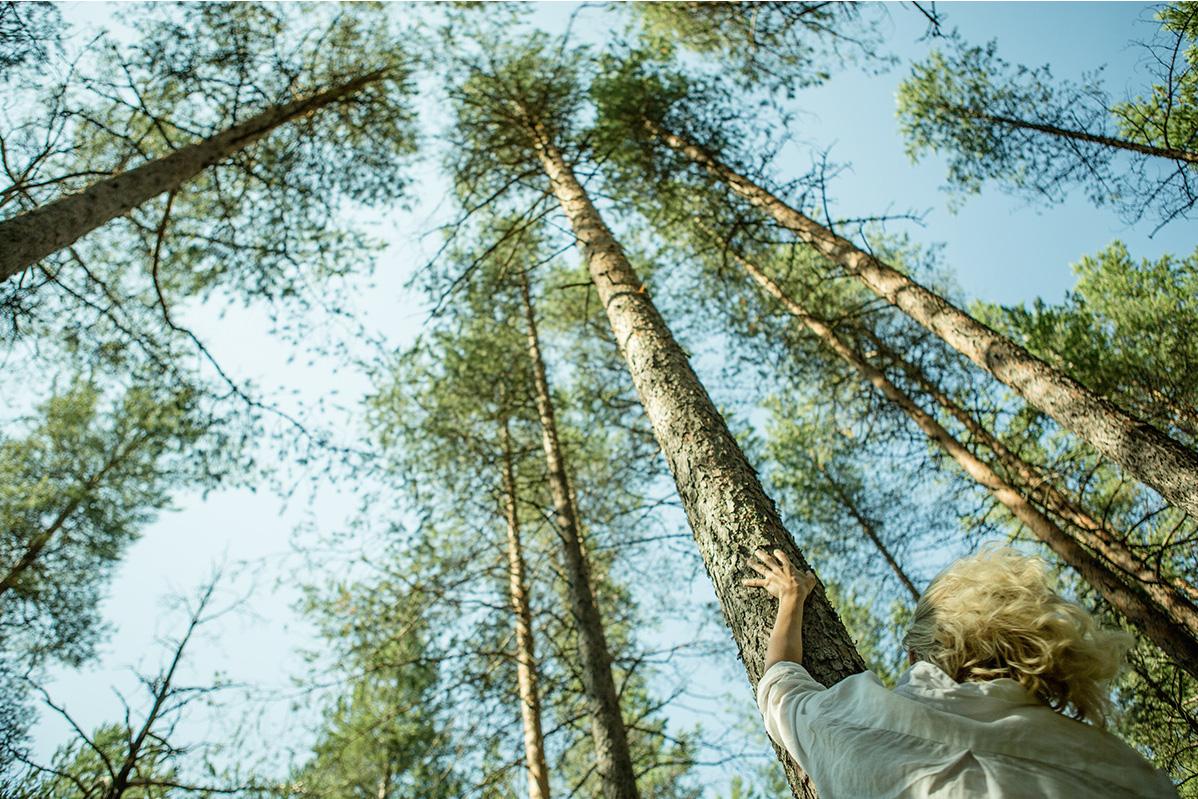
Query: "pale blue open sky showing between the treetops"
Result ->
[[28, 2, 1194, 797]]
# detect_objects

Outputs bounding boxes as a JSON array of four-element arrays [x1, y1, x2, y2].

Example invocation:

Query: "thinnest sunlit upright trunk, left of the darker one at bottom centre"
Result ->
[[503, 419, 549, 799]]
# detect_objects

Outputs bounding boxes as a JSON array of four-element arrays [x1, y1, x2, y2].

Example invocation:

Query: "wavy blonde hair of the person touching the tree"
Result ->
[[903, 547, 1132, 727]]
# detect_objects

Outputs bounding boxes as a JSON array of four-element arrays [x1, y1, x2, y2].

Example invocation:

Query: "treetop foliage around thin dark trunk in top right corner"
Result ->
[[899, 4, 1198, 225]]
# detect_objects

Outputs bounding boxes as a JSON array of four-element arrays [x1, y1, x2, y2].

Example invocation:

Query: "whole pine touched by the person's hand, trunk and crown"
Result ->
[[445, 35, 864, 795]]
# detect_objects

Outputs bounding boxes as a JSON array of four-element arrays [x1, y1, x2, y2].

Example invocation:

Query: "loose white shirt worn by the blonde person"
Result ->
[[757, 661, 1178, 799]]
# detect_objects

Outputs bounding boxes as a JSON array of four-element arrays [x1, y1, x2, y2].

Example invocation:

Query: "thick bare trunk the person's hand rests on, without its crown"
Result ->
[[531, 120, 865, 797]]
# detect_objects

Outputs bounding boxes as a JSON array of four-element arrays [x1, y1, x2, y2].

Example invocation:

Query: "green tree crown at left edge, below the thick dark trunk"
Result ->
[[0, 380, 220, 664]]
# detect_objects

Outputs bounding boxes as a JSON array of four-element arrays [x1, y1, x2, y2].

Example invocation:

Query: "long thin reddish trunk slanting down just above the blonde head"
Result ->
[[734, 241, 1198, 677]]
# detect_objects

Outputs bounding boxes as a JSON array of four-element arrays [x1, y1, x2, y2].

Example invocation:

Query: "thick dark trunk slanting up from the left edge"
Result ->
[[0, 71, 386, 280]]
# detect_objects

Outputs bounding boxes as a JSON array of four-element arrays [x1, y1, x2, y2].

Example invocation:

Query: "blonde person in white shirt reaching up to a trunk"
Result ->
[[744, 547, 1178, 799]]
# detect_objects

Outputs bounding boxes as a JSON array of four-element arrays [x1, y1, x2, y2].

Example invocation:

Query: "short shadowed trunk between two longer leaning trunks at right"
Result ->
[[863, 328, 1198, 618]]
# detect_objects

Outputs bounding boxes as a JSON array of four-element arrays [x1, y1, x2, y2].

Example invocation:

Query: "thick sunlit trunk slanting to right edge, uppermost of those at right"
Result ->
[[646, 121, 1198, 517]]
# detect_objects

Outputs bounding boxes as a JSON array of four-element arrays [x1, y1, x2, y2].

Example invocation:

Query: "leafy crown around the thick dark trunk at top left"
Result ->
[[75, 4, 415, 298]]
